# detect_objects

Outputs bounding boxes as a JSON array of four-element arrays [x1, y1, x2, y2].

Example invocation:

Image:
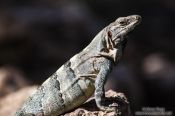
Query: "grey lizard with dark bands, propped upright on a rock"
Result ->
[[16, 15, 141, 116]]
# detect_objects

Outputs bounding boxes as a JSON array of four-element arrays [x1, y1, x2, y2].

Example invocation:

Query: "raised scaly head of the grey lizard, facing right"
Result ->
[[107, 15, 141, 45]]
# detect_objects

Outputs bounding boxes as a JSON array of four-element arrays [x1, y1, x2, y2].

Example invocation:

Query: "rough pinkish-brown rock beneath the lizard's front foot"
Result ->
[[62, 90, 132, 116]]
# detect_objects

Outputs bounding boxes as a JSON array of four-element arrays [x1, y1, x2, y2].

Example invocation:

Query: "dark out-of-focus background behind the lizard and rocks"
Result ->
[[0, 0, 175, 113]]
